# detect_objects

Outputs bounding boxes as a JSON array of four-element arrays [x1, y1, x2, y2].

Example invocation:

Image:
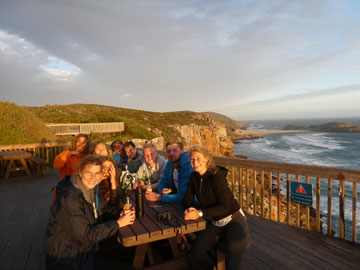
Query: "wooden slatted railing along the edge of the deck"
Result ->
[[0, 143, 360, 242]]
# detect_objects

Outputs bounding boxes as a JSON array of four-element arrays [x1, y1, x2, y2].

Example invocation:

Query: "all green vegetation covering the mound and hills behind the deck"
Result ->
[[0, 101, 245, 144]]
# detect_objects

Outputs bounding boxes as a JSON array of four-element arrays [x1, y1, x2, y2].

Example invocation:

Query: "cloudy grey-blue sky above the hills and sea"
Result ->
[[0, 0, 360, 120]]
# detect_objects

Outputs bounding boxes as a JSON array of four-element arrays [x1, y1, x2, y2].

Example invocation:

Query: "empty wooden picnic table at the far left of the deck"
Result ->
[[0, 150, 31, 179]]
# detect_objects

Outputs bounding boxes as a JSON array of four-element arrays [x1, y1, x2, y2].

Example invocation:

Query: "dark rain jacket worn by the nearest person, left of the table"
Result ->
[[45, 177, 119, 269]]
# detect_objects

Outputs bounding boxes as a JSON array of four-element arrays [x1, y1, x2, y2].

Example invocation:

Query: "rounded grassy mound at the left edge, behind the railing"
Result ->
[[0, 101, 57, 145]]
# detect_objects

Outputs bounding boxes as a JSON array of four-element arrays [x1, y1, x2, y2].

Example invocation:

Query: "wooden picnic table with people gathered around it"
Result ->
[[118, 191, 206, 269]]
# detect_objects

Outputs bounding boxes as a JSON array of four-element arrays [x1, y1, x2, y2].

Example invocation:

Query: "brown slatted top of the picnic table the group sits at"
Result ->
[[119, 192, 206, 247]]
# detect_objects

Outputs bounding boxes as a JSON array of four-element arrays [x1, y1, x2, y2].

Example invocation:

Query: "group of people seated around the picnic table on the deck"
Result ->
[[46, 134, 248, 269]]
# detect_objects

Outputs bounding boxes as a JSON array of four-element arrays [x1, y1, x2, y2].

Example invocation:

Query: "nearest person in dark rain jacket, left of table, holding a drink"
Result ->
[[46, 155, 135, 269]]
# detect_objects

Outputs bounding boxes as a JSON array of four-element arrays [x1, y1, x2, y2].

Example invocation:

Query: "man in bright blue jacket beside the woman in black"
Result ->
[[145, 141, 194, 203]]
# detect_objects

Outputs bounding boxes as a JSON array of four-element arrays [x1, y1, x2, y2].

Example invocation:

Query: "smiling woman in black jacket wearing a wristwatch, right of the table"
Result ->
[[184, 146, 248, 269]]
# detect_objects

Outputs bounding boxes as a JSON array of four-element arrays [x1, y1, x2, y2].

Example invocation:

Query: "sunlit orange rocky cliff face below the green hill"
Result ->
[[170, 113, 234, 157]]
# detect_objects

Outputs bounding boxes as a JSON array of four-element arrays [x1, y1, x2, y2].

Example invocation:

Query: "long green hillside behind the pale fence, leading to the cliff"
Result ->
[[28, 104, 211, 140]]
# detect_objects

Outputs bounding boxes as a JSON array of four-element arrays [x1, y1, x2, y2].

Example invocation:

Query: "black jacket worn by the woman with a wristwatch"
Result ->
[[184, 166, 240, 220]]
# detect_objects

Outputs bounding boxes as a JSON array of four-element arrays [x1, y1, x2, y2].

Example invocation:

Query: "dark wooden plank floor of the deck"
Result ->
[[0, 170, 360, 270]]
